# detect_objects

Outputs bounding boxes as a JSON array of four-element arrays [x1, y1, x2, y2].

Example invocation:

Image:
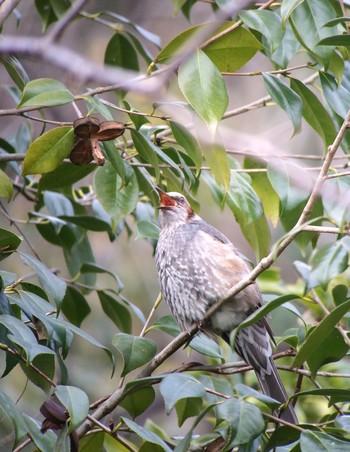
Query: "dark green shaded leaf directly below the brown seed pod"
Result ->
[[39, 162, 96, 190]]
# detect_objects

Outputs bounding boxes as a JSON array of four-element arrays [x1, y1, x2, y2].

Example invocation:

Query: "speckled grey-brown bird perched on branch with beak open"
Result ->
[[155, 187, 298, 424]]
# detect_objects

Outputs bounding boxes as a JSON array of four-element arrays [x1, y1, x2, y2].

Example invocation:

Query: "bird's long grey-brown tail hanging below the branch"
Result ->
[[231, 319, 298, 424]]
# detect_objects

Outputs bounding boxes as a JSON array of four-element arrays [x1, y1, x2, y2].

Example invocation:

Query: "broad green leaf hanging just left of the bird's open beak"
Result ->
[[94, 162, 139, 231]]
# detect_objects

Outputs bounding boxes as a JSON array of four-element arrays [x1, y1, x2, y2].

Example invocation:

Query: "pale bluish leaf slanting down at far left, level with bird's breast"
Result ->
[[19, 252, 67, 307]]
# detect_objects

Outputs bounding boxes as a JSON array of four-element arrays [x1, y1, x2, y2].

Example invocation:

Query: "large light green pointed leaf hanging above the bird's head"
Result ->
[[178, 49, 228, 130]]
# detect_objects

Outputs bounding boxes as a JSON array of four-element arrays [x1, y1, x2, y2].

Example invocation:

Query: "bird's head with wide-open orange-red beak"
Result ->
[[157, 188, 195, 228]]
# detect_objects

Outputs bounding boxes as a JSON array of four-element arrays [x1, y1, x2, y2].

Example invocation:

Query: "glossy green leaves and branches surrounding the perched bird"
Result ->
[[0, 0, 350, 452]]
